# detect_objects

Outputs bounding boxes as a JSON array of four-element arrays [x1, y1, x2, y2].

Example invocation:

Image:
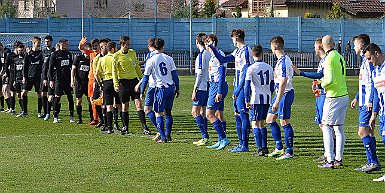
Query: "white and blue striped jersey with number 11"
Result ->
[[245, 60, 274, 104]]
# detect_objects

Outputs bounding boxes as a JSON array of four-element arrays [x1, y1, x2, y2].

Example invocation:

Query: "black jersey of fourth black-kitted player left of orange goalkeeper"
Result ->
[[24, 50, 44, 79]]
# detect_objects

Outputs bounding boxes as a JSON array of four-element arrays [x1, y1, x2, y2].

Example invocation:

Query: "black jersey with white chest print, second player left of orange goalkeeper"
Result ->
[[48, 50, 73, 82]]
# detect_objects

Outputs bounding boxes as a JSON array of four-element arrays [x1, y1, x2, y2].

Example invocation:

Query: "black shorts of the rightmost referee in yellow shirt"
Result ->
[[119, 78, 140, 103]]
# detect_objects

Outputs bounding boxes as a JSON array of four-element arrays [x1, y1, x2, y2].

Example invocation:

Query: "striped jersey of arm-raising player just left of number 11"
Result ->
[[231, 46, 253, 87]]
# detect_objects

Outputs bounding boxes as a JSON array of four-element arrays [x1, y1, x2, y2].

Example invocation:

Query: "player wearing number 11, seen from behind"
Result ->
[[244, 45, 274, 156]]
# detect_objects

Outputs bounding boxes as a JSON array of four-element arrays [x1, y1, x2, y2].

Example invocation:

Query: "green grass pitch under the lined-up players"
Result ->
[[0, 77, 385, 192]]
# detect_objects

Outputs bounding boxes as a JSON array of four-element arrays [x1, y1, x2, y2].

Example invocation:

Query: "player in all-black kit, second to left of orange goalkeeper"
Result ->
[[48, 39, 75, 123]]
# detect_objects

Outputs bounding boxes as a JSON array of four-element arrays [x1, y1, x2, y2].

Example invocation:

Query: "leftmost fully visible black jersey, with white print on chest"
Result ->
[[7, 54, 27, 83]]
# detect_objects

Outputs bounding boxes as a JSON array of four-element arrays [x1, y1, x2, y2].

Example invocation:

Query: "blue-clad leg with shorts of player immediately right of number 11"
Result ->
[[277, 90, 294, 160]]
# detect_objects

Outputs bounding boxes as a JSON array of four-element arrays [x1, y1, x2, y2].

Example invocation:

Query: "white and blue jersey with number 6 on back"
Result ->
[[144, 53, 176, 88]]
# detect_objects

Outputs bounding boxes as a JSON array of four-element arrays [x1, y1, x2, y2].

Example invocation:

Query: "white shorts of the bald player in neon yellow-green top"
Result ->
[[322, 96, 349, 125]]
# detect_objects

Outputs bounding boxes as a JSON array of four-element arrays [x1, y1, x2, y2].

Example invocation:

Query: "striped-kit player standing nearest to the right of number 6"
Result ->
[[191, 33, 211, 146]]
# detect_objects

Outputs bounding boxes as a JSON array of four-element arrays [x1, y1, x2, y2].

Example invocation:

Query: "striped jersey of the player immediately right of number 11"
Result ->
[[274, 54, 294, 93]]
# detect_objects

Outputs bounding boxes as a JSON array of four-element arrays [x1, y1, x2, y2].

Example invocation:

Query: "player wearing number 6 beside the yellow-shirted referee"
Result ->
[[140, 38, 179, 143]]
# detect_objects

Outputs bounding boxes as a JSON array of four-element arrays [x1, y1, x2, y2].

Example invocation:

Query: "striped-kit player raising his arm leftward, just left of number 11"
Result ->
[[210, 29, 253, 152]]
